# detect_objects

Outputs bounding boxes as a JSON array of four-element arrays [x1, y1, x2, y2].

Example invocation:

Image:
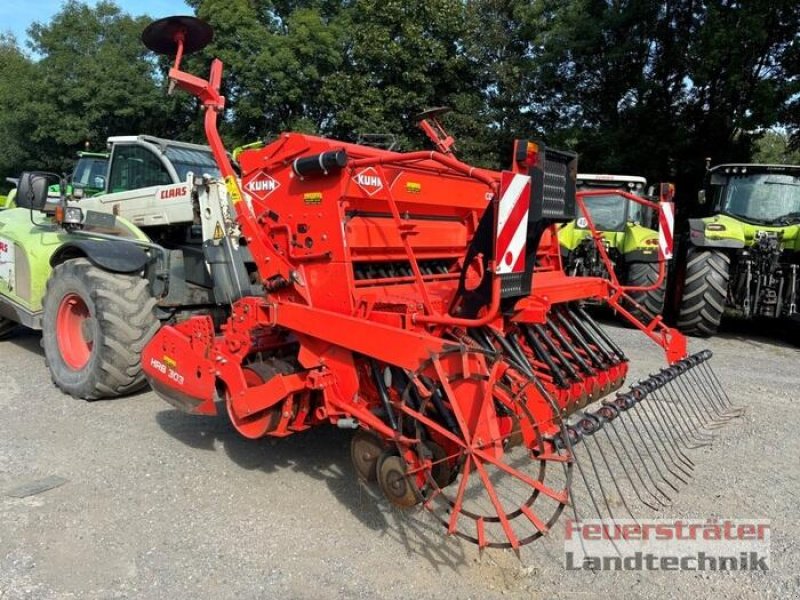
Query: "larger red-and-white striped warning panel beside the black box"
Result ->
[[494, 171, 531, 275]]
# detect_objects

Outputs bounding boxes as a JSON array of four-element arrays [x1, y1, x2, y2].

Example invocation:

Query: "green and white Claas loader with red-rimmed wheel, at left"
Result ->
[[0, 136, 257, 399]]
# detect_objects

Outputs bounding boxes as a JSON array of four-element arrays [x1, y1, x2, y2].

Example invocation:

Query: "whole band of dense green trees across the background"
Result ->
[[0, 0, 800, 194]]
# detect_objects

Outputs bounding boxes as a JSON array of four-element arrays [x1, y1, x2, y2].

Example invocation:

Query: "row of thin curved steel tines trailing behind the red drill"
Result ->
[[553, 350, 741, 540]]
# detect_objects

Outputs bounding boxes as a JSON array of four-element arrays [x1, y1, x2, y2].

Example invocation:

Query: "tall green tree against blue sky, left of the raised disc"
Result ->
[[26, 0, 175, 169]]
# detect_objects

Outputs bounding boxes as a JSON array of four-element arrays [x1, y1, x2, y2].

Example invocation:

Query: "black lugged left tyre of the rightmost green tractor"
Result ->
[[677, 248, 731, 337]]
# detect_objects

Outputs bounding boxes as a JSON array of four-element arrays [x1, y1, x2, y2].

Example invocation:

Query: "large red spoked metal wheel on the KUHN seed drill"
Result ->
[[400, 349, 572, 549]]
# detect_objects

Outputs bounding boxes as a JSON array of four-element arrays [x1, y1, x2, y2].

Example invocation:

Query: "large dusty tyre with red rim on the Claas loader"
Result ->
[[42, 258, 159, 400]]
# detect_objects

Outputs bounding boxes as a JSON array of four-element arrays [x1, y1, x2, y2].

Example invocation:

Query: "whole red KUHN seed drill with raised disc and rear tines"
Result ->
[[142, 17, 736, 549]]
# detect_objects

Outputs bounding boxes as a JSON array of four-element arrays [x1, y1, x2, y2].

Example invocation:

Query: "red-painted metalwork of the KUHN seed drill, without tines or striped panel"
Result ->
[[138, 24, 685, 548]]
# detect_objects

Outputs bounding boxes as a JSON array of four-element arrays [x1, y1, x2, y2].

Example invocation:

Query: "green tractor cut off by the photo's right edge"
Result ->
[[672, 164, 800, 337]]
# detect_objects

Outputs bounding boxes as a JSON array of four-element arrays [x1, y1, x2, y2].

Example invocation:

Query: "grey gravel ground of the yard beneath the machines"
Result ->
[[0, 316, 800, 600]]
